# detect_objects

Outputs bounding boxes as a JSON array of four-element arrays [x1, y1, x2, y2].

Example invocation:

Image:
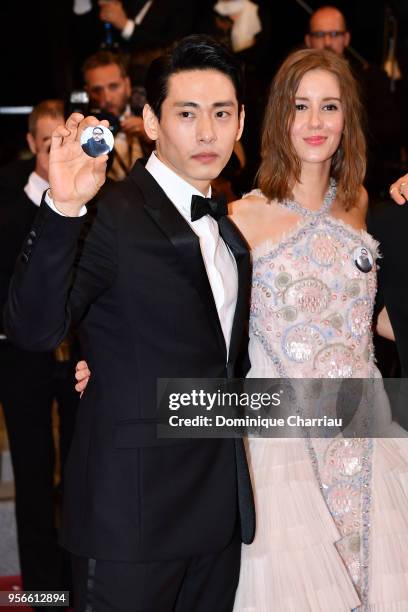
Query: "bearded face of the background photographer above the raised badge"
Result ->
[[85, 64, 131, 117]]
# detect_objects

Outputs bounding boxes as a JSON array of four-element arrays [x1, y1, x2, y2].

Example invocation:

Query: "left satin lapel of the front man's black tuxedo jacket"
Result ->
[[131, 162, 226, 352]]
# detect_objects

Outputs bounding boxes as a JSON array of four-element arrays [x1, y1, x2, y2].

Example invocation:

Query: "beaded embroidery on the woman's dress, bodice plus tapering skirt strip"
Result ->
[[244, 180, 378, 610]]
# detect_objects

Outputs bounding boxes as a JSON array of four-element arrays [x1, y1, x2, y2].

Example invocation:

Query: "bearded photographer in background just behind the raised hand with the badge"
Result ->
[[82, 51, 151, 181]]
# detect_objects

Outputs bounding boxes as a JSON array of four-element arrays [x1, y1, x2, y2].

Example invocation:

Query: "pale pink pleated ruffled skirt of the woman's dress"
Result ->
[[234, 436, 408, 612]]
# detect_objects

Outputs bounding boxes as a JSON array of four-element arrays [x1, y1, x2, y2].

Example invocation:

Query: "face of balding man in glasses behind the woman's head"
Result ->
[[305, 8, 350, 55]]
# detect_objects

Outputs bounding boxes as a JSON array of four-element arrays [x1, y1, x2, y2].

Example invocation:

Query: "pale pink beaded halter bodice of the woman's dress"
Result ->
[[250, 182, 378, 378]]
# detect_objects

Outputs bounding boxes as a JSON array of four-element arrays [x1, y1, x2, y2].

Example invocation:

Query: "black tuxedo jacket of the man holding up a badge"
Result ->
[[5, 162, 255, 561]]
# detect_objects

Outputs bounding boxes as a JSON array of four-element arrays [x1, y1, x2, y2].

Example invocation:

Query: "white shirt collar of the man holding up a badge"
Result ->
[[146, 151, 211, 222]]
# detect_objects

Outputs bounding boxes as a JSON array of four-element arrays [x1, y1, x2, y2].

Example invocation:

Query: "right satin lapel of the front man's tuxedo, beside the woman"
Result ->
[[218, 217, 251, 362]]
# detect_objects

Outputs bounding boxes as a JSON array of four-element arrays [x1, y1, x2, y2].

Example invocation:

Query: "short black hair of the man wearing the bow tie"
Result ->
[[145, 34, 244, 119]]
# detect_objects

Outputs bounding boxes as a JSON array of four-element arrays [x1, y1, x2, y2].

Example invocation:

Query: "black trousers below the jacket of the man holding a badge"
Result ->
[[72, 529, 241, 612]]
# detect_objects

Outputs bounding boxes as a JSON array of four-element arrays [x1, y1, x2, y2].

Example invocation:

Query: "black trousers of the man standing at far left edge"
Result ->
[[0, 341, 78, 590]]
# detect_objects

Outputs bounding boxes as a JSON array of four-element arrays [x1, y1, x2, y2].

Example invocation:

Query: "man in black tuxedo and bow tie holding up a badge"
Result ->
[[5, 36, 255, 612]]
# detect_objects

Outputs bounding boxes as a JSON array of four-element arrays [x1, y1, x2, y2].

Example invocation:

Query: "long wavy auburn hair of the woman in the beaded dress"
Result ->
[[257, 49, 366, 210]]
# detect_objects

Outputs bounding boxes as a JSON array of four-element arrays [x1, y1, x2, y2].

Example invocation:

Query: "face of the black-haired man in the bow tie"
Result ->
[[143, 70, 244, 193]]
